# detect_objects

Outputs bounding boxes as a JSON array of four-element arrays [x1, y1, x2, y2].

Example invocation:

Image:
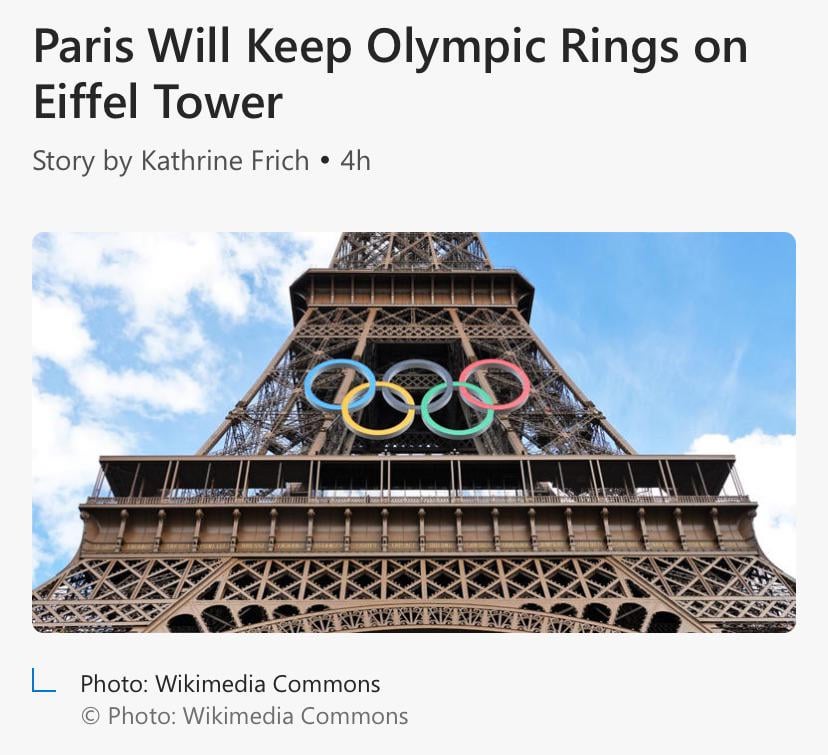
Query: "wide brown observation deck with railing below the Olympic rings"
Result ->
[[80, 455, 757, 555]]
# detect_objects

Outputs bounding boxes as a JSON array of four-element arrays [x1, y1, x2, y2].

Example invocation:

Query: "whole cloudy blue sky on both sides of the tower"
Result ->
[[32, 233, 795, 582]]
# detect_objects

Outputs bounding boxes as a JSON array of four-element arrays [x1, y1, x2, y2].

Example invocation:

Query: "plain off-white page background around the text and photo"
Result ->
[[0, 0, 828, 753]]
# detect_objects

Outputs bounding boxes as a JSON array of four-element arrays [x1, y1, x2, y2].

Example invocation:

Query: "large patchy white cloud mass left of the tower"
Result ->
[[32, 233, 338, 580]]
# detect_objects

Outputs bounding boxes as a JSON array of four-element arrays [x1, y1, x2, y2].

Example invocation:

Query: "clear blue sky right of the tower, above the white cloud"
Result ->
[[484, 233, 796, 453]]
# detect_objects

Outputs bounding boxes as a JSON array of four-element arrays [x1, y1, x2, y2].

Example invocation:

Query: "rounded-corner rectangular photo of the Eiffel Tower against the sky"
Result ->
[[32, 231, 796, 634]]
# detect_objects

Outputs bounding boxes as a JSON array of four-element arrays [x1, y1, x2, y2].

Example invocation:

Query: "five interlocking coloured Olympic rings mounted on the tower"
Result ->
[[304, 359, 532, 440]]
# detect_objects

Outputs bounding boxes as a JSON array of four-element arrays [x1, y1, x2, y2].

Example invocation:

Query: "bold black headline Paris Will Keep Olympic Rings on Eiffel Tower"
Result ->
[[35, 26, 747, 120]]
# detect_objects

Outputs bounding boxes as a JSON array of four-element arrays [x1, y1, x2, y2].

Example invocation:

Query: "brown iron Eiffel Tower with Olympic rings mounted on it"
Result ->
[[32, 233, 795, 633]]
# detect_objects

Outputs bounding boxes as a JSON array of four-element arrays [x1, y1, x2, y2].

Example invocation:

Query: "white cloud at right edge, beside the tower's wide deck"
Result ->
[[690, 430, 796, 574]]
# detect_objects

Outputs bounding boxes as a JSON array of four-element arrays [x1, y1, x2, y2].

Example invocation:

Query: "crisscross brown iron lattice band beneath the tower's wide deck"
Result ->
[[35, 554, 794, 632]]
